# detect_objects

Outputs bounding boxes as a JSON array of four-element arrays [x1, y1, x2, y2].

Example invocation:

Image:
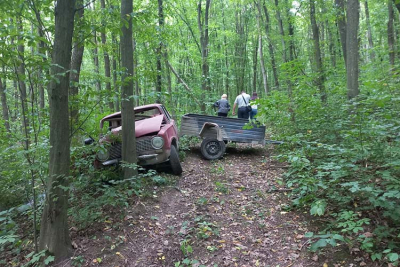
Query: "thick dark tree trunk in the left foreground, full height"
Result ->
[[39, 0, 75, 263]]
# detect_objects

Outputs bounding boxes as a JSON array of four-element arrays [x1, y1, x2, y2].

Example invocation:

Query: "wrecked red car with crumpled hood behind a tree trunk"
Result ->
[[91, 104, 182, 175]]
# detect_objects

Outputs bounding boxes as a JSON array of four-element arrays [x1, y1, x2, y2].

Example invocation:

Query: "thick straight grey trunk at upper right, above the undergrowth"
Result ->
[[346, 0, 360, 99]]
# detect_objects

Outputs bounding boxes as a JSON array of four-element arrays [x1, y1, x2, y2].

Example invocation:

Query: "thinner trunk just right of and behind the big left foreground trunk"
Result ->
[[69, 0, 85, 134]]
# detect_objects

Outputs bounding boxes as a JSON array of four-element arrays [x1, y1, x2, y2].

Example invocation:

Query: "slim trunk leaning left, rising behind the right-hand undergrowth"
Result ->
[[310, 0, 326, 102]]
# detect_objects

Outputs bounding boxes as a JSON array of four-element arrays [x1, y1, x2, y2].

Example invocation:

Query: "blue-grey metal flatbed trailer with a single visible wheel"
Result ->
[[179, 113, 265, 159]]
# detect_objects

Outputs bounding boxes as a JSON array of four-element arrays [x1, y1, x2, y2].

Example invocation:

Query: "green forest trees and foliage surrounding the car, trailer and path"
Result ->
[[0, 0, 400, 266]]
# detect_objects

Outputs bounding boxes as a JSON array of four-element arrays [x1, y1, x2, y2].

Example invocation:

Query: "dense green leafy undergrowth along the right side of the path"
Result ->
[[258, 78, 400, 266]]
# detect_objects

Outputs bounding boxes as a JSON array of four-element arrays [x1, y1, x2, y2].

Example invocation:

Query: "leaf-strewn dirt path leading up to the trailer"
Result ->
[[69, 145, 377, 267]]
